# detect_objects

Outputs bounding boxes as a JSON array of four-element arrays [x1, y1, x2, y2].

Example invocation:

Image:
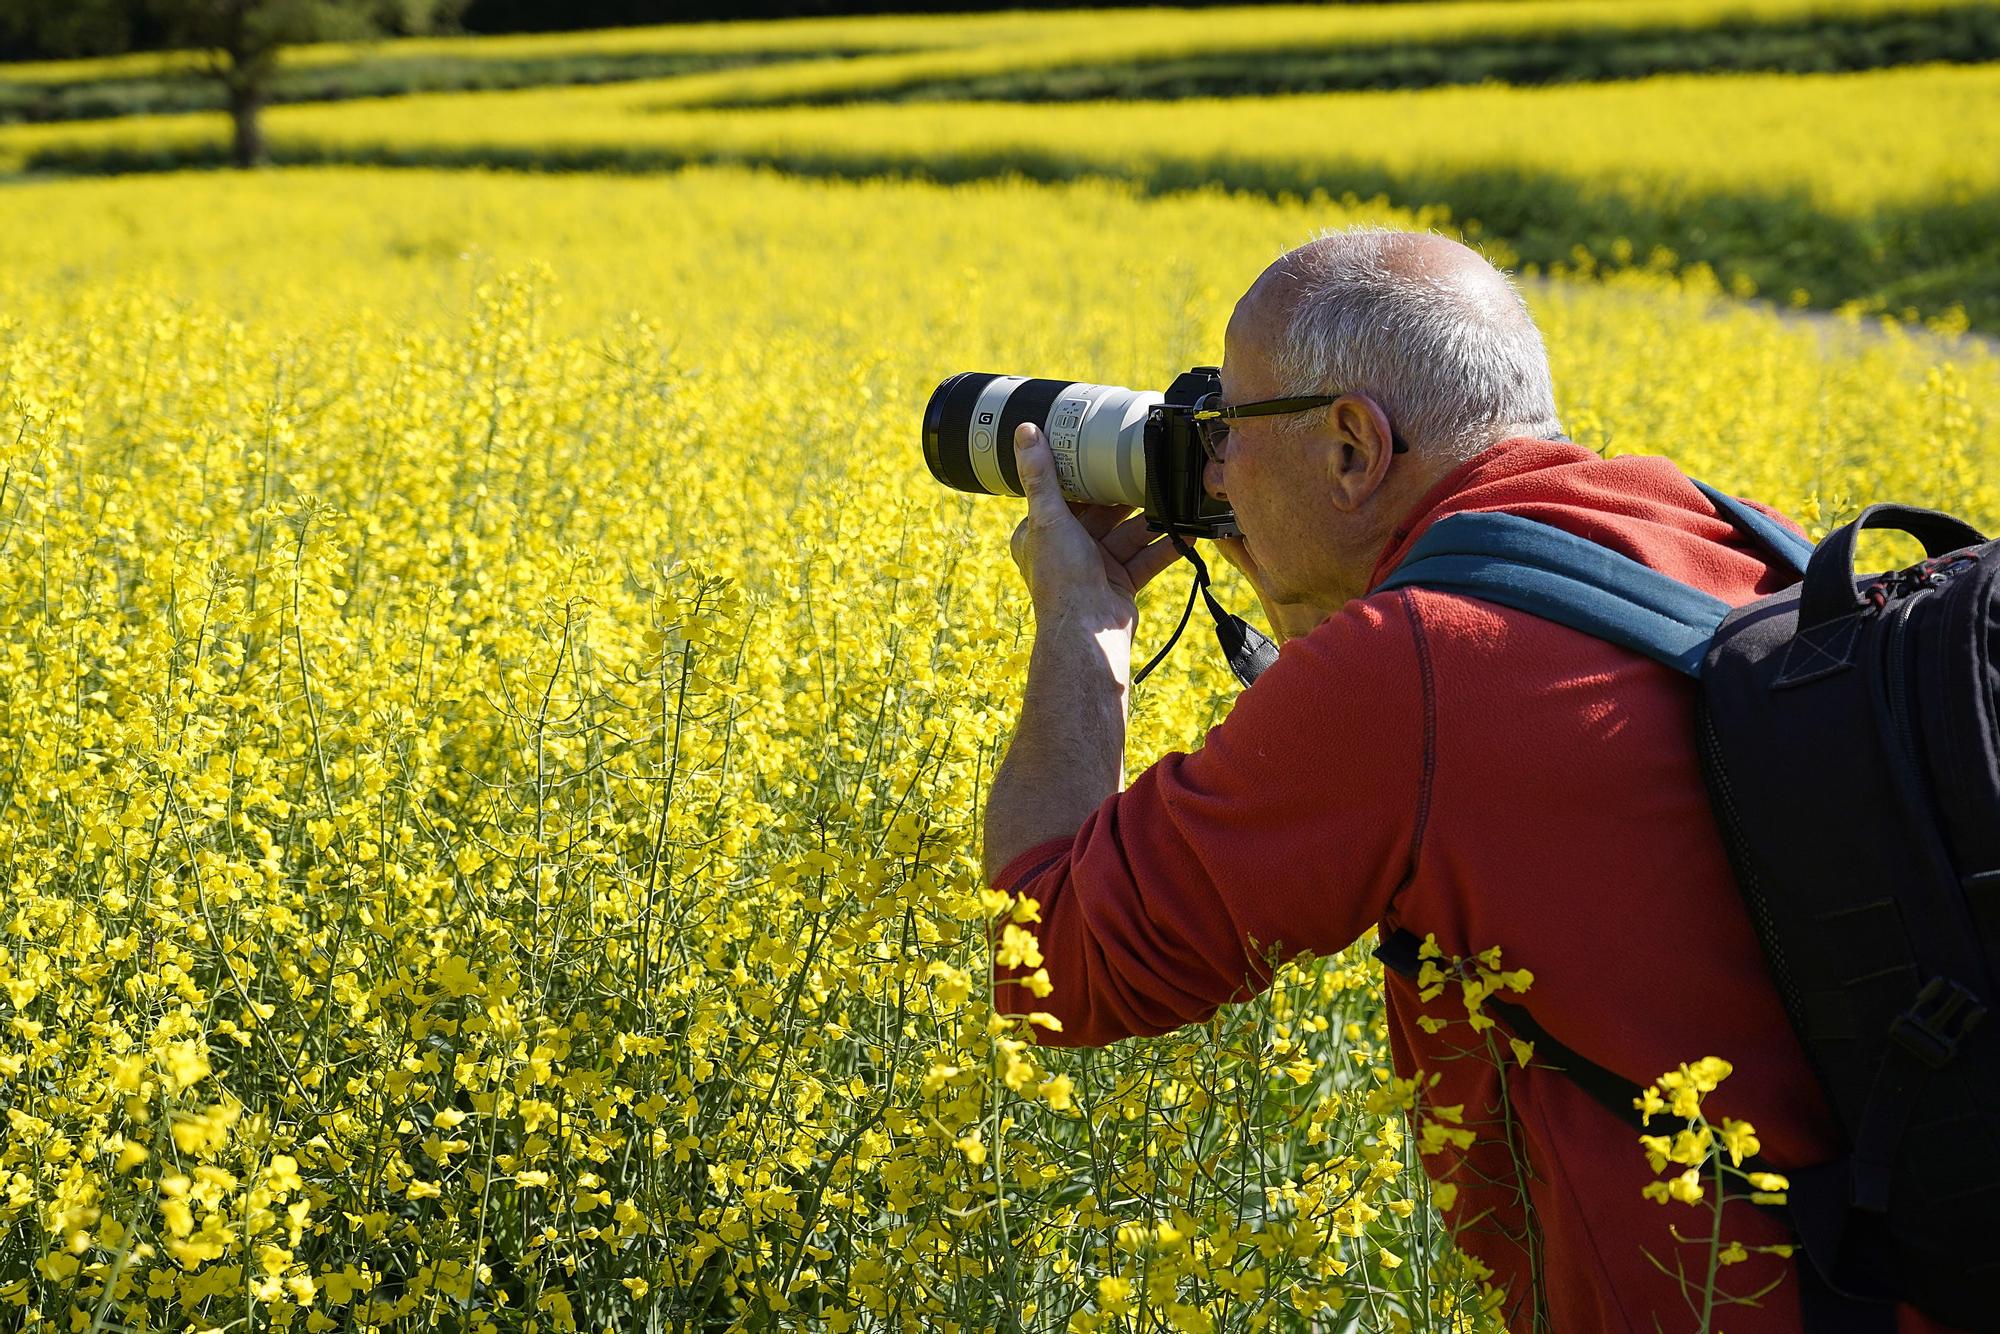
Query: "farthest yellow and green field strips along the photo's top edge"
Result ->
[[0, 0, 2000, 120]]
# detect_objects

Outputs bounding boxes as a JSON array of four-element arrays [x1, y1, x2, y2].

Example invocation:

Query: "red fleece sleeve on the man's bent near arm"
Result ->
[[994, 592, 1432, 1046]]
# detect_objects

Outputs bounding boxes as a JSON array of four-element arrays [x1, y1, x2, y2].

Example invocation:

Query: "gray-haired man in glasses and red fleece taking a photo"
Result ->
[[986, 230, 1920, 1334]]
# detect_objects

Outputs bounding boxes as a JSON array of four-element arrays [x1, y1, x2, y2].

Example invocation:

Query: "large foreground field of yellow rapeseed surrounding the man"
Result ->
[[0, 168, 2000, 1332]]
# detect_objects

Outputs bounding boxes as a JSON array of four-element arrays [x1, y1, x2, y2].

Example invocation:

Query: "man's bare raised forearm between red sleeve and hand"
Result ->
[[984, 610, 1132, 884]]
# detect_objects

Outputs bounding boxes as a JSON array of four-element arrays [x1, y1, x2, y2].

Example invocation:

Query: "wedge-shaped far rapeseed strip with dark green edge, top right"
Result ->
[[628, 0, 1996, 106]]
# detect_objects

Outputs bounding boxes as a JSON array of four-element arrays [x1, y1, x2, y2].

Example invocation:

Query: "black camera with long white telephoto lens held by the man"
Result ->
[[924, 366, 1240, 538]]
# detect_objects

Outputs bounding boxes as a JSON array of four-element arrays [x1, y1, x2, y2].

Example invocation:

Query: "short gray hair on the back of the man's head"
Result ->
[[1276, 226, 1562, 462]]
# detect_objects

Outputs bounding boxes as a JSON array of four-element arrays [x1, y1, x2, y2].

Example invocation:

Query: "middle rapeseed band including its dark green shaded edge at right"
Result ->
[[15, 66, 2000, 328]]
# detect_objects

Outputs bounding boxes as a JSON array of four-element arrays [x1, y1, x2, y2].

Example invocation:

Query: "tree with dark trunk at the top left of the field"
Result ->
[[142, 0, 466, 168]]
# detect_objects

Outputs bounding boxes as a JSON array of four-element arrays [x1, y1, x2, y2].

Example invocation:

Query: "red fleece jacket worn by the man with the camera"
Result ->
[[996, 440, 1924, 1334]]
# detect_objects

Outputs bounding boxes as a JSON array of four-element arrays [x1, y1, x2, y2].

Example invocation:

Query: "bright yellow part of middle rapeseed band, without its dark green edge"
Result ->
[[11, 66, 2000, 222]]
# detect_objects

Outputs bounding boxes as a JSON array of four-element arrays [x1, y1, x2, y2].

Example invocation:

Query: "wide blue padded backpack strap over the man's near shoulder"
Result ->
[[1374, 512, 1730, 676]]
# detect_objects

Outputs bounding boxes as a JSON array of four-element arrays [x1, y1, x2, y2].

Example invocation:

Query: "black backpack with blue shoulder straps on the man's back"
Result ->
[[1378, 482, 2000, 1330]]
